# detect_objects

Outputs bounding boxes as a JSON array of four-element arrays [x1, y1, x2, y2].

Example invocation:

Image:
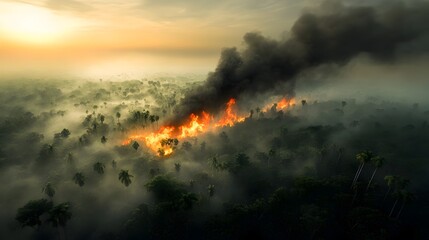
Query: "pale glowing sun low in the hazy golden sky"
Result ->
[[0, 4, 73, 43]]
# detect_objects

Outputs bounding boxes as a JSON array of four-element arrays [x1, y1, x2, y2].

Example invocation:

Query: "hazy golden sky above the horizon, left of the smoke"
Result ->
[[0, 0, 321, 77]]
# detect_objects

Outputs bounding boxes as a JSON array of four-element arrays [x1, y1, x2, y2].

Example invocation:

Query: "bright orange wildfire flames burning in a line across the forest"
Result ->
[[122, 98, 295, 157]]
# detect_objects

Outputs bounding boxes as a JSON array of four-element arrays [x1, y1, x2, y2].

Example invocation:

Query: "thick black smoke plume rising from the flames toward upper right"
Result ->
[[173, 2, 429, 122]]
